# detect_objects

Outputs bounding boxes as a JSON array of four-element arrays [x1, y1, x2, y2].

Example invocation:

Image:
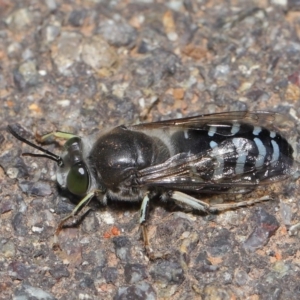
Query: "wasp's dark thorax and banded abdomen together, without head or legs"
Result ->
[[88, 113, 294, 201]]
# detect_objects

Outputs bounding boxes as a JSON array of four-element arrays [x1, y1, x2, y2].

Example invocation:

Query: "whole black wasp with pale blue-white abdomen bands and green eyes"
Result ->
[[8, 111, 298, 256]]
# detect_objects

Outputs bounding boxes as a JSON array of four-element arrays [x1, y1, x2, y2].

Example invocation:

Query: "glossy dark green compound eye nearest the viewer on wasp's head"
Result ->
[[67, 163, 90, 196]]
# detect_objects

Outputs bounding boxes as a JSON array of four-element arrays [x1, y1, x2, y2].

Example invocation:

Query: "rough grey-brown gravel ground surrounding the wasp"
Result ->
[[0, 0, 300, 300]]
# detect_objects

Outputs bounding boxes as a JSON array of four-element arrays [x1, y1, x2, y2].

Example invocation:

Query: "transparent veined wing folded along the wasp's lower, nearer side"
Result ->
[[138, 148, 299, 193]]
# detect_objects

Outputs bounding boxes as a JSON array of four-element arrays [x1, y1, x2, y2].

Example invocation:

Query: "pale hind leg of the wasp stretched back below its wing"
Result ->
[[171, 191, 272, 213]]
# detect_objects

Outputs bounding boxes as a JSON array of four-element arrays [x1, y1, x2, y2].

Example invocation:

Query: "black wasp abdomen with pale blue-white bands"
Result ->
[[171, 123, 293, 181]]
